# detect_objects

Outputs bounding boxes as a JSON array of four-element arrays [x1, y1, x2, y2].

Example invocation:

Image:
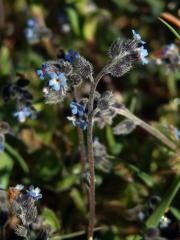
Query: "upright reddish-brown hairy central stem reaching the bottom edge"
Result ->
[[87, 70, 104, 240]]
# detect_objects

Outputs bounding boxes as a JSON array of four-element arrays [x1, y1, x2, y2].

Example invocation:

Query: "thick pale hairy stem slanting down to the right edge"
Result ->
[[115, 108, 177, 150]]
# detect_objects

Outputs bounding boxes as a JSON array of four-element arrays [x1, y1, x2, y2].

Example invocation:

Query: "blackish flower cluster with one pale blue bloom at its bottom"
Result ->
[[3, 74, 36, 123]]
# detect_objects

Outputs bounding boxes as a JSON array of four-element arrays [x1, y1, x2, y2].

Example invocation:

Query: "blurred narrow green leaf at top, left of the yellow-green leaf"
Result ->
[[66, 8, 80, 35]]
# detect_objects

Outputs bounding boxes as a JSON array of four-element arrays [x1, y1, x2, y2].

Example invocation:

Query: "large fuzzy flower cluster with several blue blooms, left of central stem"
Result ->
[[37, 49, 91, 103]]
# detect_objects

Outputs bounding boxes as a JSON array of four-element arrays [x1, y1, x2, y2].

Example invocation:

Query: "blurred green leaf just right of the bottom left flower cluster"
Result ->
[[42, 208, 61, 230]]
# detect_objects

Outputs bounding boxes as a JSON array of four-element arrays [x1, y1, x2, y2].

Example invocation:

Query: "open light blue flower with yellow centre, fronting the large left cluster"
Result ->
[[49, 73, 66, 91]]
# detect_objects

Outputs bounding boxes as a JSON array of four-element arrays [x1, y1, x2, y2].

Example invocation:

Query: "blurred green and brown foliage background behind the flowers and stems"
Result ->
[[0, 0, 180, 240]]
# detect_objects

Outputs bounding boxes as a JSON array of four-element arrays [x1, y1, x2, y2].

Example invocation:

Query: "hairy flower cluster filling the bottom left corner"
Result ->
[[0, 184, 52, 240]]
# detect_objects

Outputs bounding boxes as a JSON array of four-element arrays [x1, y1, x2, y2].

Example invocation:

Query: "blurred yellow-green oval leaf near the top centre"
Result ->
[[83, 15, 98, 41]]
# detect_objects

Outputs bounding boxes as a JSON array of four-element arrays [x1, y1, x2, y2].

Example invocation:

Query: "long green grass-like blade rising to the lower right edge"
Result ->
[[146, 176, 180, 228]]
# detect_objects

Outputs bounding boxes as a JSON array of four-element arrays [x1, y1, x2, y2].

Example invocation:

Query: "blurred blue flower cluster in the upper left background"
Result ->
[[25, 18, 51, 44]]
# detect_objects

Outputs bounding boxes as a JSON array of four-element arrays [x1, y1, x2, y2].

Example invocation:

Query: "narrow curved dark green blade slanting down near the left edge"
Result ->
[[5, 143, 29, 173]]
